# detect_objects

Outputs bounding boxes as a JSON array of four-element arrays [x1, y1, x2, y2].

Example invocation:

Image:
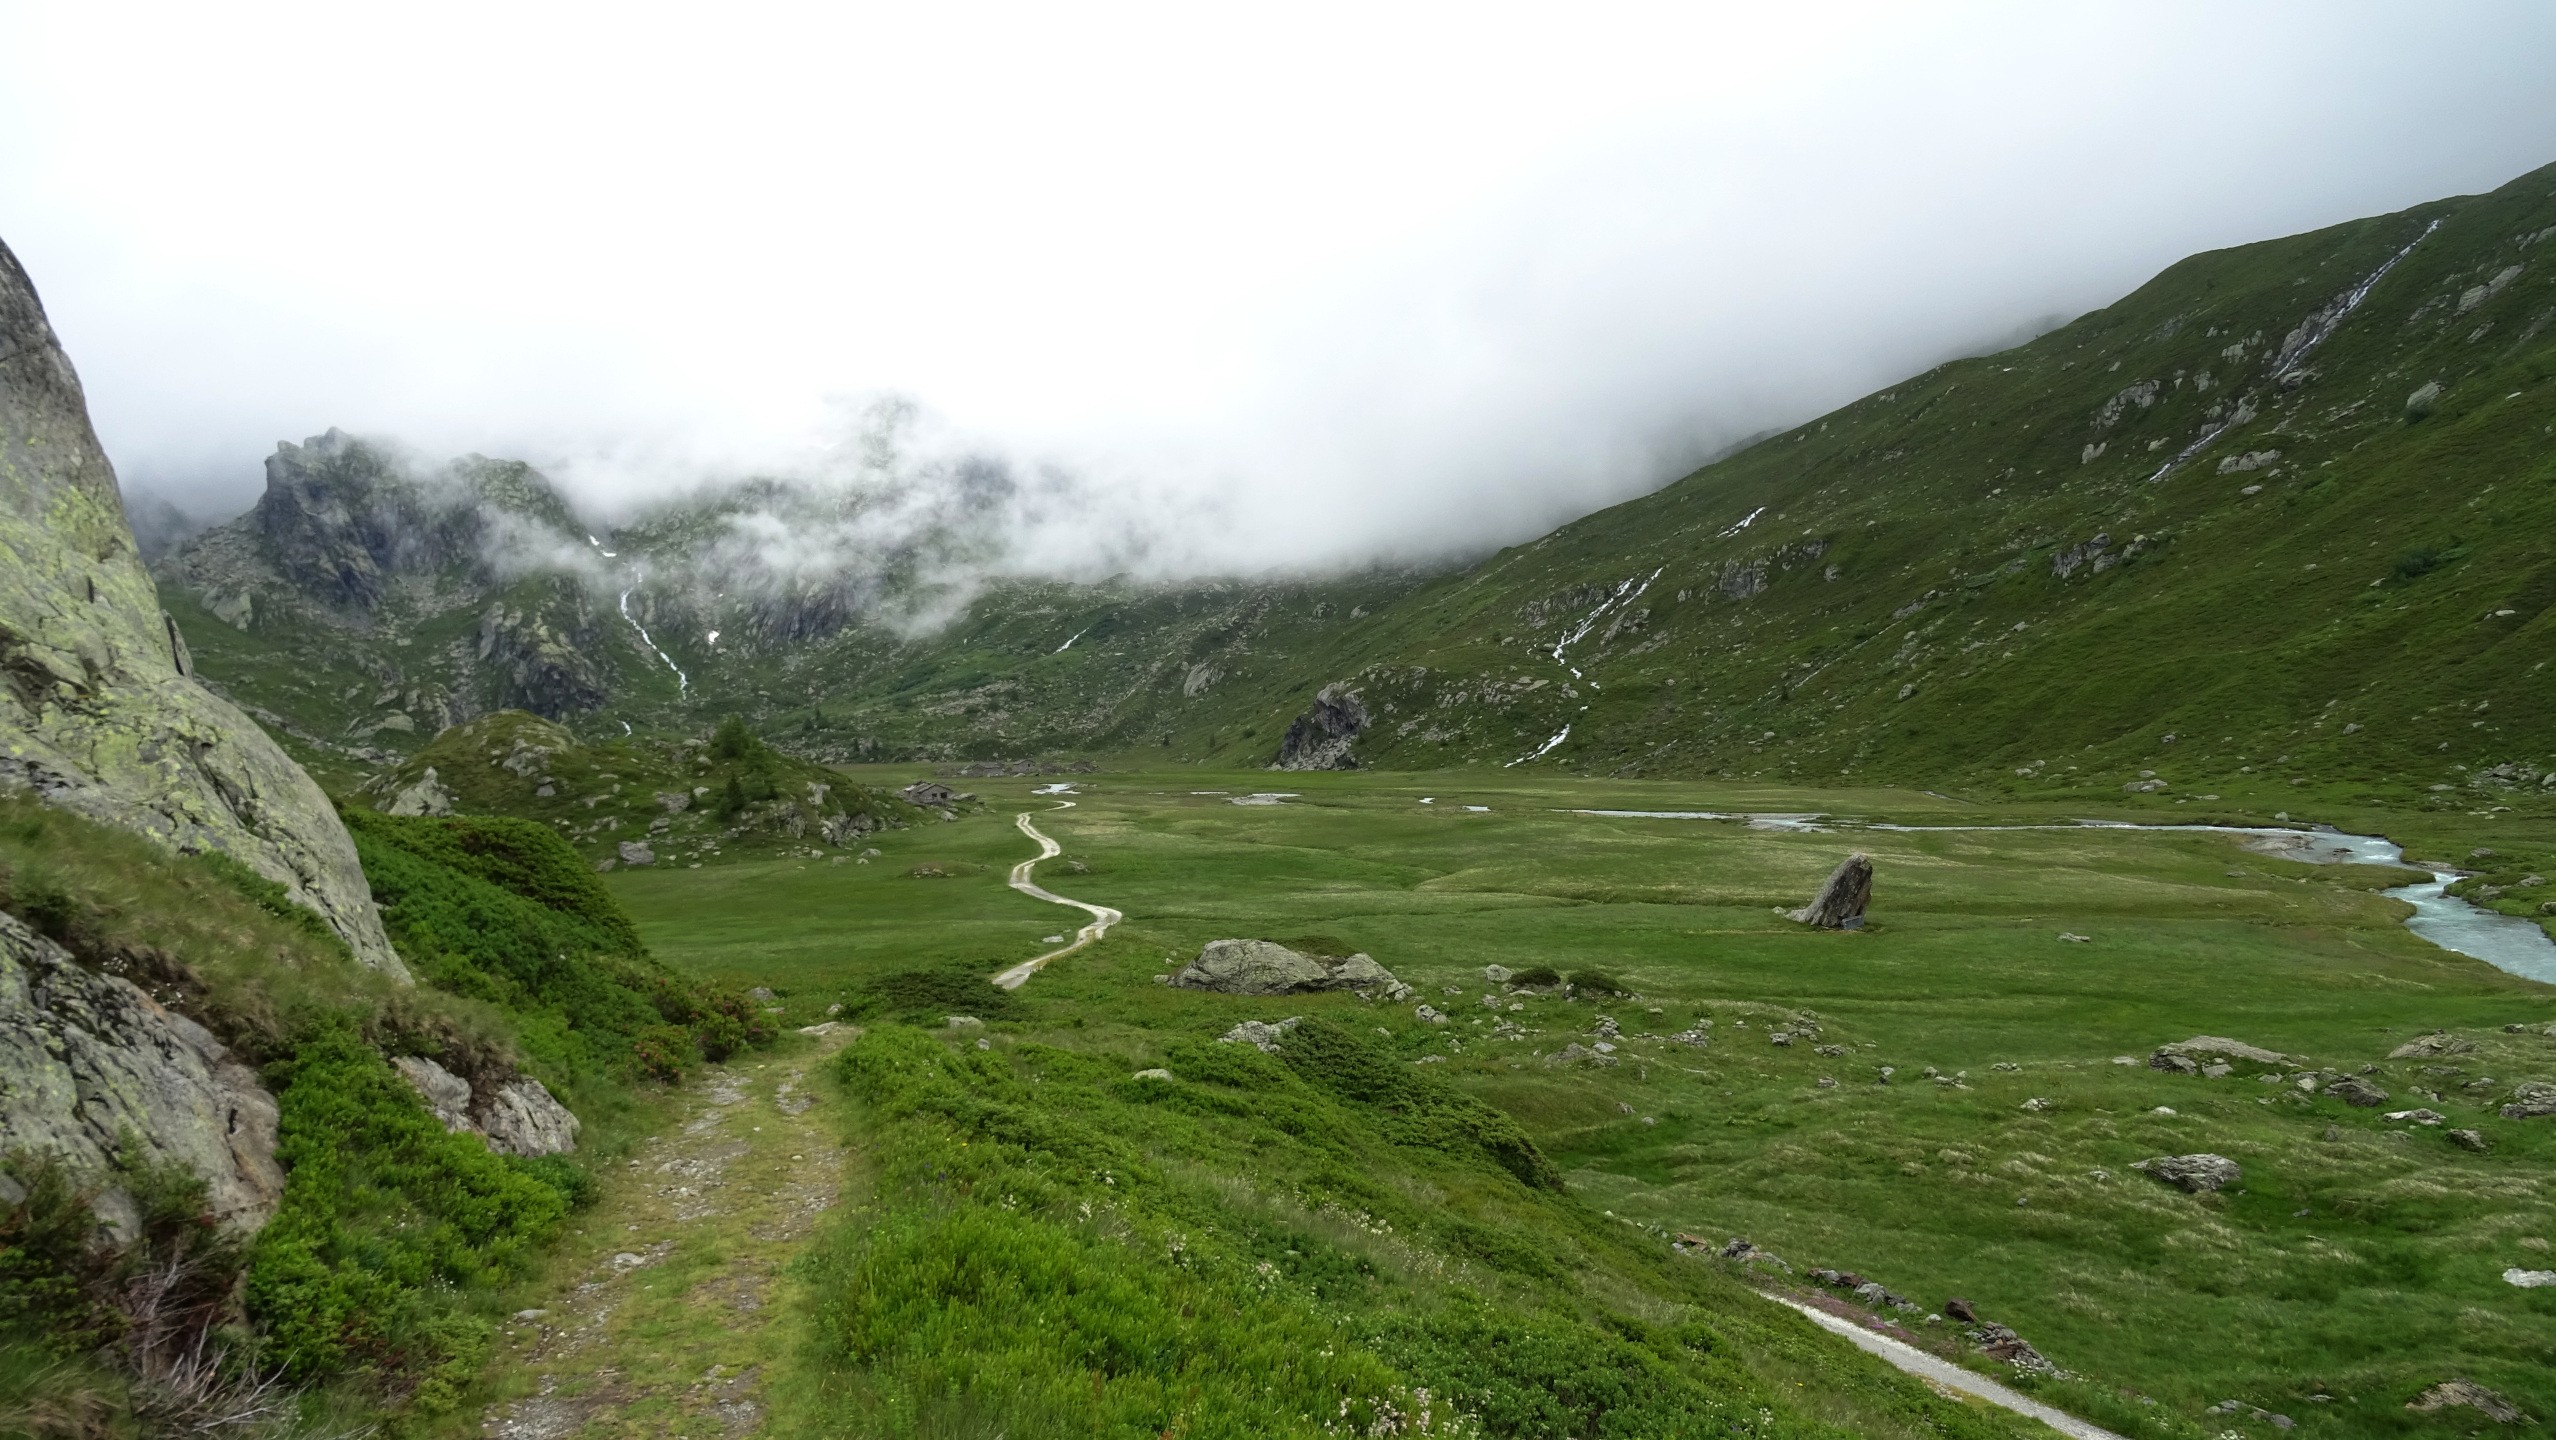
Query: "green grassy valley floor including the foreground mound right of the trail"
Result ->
[[606, 772, 2556, 1437]]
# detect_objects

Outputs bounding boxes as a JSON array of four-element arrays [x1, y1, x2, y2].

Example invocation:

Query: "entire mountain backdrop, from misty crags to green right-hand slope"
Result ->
[[161, 166, 2556, 813]]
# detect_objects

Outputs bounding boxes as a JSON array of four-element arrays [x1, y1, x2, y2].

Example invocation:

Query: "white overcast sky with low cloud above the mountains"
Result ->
[[0, 0, 2556, 568]]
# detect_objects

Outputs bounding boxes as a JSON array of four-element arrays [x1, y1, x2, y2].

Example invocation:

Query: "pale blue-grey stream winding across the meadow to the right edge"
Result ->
[[1572, 811, 2556, 985]]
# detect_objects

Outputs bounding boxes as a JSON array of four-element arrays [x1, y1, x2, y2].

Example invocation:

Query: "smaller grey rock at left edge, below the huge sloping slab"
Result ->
[[0, 913, 284, 1230]]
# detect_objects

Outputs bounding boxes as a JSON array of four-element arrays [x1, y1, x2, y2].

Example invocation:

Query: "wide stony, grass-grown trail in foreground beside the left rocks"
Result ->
[[481, 1026, 856, 1440]]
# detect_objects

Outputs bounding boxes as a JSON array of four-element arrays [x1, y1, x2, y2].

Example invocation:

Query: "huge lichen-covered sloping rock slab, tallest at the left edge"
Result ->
[[0, 236, 406, 977]]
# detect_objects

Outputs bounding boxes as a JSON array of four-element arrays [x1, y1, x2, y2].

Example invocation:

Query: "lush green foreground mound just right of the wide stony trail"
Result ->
[[777, 1021, 2019, 1440]]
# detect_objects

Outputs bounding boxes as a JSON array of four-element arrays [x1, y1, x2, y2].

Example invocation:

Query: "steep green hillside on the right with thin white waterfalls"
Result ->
[[1181, 169, 2556, 803]]
